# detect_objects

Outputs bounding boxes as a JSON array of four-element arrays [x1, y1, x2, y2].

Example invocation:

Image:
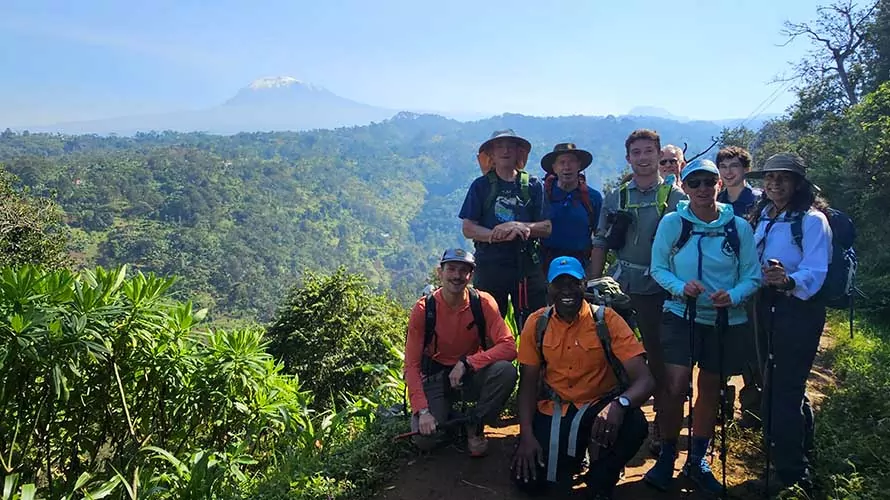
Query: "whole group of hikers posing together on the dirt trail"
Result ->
[[405, 129, 832, 498]]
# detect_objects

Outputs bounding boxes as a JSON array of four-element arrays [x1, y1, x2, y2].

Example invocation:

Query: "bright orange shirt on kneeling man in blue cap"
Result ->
[[518, 302, 646, 415]]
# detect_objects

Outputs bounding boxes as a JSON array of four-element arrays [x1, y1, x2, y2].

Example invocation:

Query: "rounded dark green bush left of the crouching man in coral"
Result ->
[[266, 267, 407, 409]]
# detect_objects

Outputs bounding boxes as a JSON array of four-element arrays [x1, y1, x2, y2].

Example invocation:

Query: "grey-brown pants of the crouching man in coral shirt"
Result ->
[[411, 361, 518, 438]]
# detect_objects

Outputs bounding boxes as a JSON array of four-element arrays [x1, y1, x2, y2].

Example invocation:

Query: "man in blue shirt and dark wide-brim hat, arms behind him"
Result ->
[[541, 142, 603, 273]]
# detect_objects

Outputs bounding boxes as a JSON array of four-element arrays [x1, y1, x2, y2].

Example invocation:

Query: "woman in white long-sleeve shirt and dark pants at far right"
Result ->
[[748, 153, 831, 491]]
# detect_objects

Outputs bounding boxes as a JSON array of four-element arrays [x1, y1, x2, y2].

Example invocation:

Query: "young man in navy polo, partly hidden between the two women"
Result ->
[[717, 146, 763, 428]]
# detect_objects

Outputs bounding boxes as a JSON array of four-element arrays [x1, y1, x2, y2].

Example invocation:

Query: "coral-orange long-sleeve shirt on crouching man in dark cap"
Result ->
[[404, 289, 516, 412]]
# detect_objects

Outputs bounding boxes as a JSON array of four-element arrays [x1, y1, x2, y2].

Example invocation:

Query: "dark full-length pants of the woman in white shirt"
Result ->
[[757, 291, 825, 484]]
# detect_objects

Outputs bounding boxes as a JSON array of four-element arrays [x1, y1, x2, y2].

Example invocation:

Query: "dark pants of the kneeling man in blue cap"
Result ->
[[510, 403, 649, 493]]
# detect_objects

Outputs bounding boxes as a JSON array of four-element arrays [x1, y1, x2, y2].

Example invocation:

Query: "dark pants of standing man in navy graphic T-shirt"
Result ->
[[473, 257, 547, 322]]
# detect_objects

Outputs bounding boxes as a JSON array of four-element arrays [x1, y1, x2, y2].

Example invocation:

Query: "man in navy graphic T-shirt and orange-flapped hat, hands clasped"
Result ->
[[458, 129, 550, 327]]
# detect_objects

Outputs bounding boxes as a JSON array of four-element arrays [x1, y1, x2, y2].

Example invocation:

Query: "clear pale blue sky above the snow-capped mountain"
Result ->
[[0, 0, 816, 127]]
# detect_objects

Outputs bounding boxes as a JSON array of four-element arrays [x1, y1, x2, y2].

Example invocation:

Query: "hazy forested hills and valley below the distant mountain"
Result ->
[[0, 113, 719, 319]]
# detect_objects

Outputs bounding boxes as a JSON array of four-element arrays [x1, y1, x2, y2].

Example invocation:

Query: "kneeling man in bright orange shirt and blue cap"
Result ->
[[511, 257, 655, 499]]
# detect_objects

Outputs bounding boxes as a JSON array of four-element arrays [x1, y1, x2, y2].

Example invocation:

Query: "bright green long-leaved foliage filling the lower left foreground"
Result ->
[[0, 266, 403, 499]]
